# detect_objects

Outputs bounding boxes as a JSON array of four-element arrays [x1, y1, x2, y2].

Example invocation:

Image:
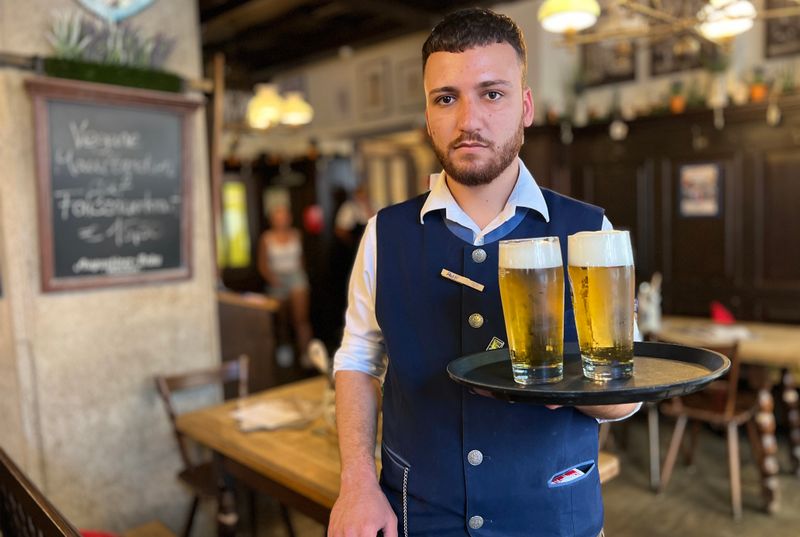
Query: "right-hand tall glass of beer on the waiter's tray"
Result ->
[[567, 231, 634, 380]]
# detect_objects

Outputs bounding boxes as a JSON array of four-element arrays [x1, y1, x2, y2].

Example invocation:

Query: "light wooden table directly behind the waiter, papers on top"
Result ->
[[177, 377, 619, 530]]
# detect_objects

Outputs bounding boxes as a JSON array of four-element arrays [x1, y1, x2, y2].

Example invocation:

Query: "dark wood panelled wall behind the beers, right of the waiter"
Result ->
[[522, 97, 800, 322]]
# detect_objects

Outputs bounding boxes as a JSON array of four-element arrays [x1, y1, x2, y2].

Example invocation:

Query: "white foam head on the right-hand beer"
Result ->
[[567, 231, 633, 267]]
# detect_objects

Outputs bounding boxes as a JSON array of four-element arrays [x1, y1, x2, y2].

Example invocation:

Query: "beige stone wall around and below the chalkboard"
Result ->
[[0, 0, 219, 531]]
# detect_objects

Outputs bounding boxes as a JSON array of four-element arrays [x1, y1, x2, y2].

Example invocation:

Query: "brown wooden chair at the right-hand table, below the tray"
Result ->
[[659, 343, 761, 520]]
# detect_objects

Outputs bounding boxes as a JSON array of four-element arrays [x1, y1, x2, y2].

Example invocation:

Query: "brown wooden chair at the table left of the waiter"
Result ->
[[155, 354, 294, 537]]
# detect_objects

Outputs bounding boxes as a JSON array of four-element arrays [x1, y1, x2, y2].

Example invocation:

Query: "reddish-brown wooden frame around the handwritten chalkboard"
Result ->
[[25, 77, 203, 292]]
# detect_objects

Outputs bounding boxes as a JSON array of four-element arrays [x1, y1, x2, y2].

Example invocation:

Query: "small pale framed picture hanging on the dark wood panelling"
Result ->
[[678, 162, 722, 218]]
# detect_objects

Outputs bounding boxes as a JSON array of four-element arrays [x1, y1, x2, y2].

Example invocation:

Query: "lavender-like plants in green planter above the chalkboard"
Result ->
[[43, 11, 183, 92]]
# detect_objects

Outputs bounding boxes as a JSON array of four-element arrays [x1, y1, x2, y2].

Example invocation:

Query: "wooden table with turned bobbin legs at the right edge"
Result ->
[[656, 316, 800, 511]]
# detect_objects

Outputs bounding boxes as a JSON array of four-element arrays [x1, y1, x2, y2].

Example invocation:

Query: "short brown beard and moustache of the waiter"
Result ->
[[431, 118, 525, 186]]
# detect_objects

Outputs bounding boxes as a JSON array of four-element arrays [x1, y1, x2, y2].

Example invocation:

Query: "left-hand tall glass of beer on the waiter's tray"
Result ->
[[498, 237, 564, 384]]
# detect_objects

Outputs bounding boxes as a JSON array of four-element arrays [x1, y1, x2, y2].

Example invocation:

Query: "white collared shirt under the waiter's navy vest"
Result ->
[[333, 158, 641, 421]]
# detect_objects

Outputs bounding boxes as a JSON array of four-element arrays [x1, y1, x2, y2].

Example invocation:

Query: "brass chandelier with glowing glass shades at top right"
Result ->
[[539, 0, 800, 45]]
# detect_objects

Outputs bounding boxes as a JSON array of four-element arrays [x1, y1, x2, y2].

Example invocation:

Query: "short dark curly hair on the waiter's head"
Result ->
[[422, 7, 528, 80]]
